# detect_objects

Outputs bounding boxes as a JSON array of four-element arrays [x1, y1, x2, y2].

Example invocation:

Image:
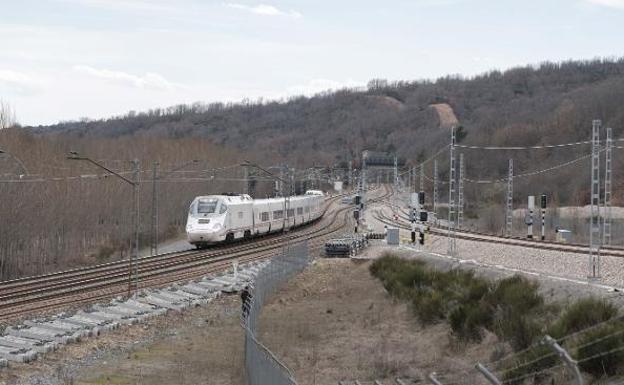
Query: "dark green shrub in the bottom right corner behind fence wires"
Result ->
[[576, 322, 624, 377]]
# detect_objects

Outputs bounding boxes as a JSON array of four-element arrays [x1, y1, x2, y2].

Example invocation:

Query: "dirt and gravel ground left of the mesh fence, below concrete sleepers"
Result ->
[[0, 295, 244, 385]]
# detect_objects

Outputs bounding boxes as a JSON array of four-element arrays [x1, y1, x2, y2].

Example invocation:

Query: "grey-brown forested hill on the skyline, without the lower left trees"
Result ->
[[38, 59, 624, 166]]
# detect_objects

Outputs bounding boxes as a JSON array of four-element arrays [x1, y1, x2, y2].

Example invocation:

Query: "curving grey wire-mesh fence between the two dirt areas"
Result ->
[[242, 242, 310, 385]]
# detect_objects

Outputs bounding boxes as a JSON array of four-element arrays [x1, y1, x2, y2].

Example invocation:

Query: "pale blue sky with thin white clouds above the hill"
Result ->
[[0, 0, 624, 124]]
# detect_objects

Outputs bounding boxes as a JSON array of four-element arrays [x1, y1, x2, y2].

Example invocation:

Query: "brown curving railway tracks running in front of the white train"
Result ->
[[0, 189, 390, 321]]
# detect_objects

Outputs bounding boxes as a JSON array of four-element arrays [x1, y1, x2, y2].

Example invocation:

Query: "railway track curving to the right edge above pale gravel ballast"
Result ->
[[373, 196, 624, 258]]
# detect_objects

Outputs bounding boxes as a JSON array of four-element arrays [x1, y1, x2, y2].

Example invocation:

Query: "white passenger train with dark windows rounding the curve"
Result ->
[[186, 190, 324, 248]]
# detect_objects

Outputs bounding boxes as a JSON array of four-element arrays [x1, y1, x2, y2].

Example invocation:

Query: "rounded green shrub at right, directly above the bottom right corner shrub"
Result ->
[[549, 297, 618, 338]]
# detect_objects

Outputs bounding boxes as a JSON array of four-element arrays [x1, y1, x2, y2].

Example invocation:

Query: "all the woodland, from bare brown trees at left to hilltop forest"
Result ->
[[0, 59, 624, 279]]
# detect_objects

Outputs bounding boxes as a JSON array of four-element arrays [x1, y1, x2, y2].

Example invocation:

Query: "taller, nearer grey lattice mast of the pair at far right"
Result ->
[[588, 120, 601, 278]]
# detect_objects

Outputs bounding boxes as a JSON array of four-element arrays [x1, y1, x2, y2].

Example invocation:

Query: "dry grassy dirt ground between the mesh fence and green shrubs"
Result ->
[[260, 255, 495, 385]]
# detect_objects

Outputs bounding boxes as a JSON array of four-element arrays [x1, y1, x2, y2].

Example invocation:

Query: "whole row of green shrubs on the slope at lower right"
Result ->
[[370, 254, 624, 384]]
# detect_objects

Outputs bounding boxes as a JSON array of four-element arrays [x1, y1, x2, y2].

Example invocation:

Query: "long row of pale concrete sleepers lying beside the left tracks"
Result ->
[[0, 261, 268, 367]]
